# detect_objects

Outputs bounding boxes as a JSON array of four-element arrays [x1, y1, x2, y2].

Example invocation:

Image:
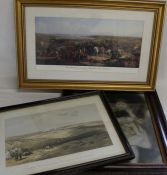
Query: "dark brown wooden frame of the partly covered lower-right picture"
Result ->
[[64, 91, 167, 175]]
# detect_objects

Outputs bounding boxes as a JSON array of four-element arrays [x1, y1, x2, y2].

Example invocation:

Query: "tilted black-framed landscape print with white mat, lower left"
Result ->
[[0, 93, 134, 175]]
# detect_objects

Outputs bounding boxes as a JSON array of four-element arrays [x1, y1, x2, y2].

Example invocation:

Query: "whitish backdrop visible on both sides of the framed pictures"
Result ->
[[0, 0, 167, 119]]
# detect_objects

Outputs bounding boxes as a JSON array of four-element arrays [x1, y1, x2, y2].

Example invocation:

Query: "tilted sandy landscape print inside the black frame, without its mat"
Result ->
[[5, 104, 112, 167]]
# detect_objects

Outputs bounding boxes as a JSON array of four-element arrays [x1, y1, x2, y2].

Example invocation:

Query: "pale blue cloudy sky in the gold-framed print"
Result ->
[[35, 17, 144, 37]]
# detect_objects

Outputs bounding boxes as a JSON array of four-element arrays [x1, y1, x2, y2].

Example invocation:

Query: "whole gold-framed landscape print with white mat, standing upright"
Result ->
[[16, 0, 165, 91]]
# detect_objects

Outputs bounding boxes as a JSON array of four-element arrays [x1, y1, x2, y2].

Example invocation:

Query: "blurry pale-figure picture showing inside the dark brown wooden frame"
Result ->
[[108, 92, 163, 163]]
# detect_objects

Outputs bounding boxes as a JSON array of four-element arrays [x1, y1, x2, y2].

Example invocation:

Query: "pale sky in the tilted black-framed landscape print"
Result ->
[[5, 104, 101, 138]]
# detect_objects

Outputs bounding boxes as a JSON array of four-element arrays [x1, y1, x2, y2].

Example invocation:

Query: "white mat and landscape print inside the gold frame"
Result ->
[[25, 7, 154, 82]]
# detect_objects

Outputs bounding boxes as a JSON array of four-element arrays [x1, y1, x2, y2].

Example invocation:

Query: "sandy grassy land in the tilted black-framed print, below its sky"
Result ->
[[6, 121, 112, 166]]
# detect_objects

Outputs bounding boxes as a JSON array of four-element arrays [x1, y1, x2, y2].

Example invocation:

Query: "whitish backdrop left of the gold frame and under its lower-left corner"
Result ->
[[0, 0, 60, 107]]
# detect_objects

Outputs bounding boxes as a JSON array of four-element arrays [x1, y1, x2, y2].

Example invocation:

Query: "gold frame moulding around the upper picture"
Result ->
[[15, 0, 165, 91]]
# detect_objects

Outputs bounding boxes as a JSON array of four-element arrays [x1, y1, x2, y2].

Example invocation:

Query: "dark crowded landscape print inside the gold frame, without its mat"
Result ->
[[35, 17, 144, 68]]
